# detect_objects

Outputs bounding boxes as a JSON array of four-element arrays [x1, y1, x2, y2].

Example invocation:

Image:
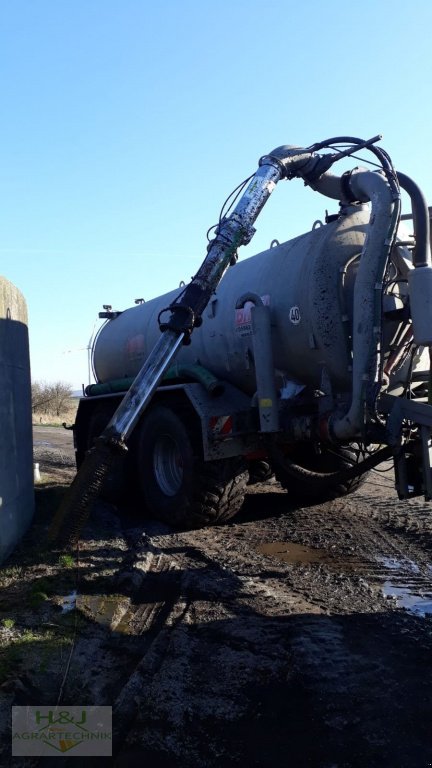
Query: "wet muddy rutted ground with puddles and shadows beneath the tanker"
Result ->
[[0, 428, 432, 768]]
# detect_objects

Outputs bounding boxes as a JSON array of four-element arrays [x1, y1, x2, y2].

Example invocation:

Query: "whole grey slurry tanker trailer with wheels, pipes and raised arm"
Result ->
[[69, 136, 432, 527]]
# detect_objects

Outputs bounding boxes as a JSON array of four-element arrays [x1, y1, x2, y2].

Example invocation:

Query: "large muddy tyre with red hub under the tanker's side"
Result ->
[[137, 405, 248, 528]]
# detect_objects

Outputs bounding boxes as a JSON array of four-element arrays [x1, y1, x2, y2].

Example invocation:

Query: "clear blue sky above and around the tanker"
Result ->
[[0, 0, 432, 388]]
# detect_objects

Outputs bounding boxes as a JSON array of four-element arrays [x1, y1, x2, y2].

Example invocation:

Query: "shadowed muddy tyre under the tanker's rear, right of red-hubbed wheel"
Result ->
[[272, 443, 369, 502]]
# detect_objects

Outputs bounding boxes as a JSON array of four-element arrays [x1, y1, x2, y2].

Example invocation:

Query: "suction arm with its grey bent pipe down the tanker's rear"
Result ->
[[101, 146, 397, 441]]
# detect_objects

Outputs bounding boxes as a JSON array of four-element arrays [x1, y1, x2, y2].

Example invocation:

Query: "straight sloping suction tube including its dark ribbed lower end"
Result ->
[[49, 141, 320, 545]]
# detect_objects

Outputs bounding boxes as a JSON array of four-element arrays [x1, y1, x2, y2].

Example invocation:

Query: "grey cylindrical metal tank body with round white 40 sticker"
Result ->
[[93, 208, 369, 394]]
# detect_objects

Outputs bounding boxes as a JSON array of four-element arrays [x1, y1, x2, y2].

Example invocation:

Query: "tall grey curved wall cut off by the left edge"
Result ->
[[0, 277, 34, 562]]
